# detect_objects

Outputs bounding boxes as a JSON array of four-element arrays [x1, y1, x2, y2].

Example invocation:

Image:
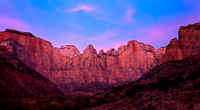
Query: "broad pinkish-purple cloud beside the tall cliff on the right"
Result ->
[[137, 11, 200, 48]]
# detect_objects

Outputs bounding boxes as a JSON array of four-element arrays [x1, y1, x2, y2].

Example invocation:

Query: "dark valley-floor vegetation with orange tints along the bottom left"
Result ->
[[0, 94, 103, 110]]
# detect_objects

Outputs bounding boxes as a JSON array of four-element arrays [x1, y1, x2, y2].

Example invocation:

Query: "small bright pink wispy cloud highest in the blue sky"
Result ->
[[67, 5, 97, 12]]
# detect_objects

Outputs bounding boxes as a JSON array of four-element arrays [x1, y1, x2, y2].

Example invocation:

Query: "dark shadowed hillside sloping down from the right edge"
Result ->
[[87, 55, 200, 110]]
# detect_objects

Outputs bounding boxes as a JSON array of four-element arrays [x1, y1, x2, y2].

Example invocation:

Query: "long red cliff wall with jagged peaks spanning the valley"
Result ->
[[0, 22, 199, 92]]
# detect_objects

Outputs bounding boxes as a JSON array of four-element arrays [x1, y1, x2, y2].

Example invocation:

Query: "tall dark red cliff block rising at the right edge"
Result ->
[[161, 23, 200, 63]]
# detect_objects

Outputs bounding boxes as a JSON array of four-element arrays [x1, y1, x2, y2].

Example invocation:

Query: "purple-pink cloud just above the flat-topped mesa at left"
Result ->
[[0, 15, 31, 31]]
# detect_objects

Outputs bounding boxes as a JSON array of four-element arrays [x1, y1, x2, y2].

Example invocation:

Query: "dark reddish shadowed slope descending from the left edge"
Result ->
[[0, 46, 60, 98]]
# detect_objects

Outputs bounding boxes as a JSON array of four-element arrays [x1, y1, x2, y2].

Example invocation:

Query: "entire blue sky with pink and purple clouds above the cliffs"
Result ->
[[0, 0, 200, 53]]
